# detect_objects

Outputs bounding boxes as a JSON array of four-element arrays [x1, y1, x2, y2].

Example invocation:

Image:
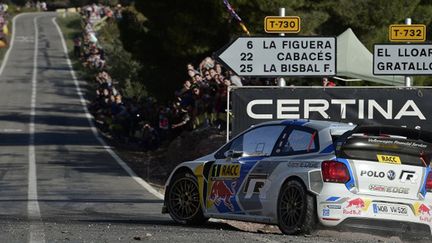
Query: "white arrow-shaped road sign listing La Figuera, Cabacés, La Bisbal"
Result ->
[[218, 36, 336, 77]]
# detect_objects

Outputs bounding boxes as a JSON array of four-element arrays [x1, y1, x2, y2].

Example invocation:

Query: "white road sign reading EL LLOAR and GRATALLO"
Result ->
[[373, 44, 432, 75]]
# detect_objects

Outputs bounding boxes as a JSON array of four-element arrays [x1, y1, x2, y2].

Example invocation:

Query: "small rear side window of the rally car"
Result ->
[[275, 128, 319, 155]]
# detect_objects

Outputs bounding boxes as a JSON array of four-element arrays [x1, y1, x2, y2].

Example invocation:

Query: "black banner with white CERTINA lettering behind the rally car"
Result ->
[[231, 87, 432, 136]]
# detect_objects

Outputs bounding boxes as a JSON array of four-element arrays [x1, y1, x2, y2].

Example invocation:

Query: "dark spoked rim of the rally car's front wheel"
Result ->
[[169, 178, 200, 219]]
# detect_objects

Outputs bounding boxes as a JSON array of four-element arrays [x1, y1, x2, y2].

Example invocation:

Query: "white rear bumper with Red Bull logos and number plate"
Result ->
[[317, 185, 432, 235]]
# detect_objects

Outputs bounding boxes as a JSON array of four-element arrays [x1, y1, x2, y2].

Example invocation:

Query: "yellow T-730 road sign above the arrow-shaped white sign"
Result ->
[[264, 16, 300, 33]]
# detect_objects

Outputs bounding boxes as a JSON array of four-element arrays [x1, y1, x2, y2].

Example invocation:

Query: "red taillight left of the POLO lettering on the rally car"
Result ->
[[321, 160, 350, 183]]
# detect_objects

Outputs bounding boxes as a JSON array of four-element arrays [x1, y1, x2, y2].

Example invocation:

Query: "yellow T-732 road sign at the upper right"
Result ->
[[389, 24, 426, 42]]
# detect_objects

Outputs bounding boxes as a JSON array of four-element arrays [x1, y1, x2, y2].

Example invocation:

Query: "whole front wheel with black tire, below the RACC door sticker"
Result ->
[[166, 173, 208, 225]]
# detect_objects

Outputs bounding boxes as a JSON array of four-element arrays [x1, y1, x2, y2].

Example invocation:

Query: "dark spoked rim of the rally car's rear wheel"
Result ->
[[280, 187, 304, 228]]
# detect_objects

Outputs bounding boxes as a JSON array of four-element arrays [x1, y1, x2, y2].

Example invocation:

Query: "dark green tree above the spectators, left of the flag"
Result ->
[[119, 0, 230, 99]]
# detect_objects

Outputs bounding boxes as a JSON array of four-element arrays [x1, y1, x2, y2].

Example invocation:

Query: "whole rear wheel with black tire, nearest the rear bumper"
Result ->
[[277, 180, 316, 235]]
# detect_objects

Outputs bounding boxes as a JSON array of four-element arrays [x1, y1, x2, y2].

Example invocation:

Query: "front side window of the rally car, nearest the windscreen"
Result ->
[[215, 125, 286, 159]]
